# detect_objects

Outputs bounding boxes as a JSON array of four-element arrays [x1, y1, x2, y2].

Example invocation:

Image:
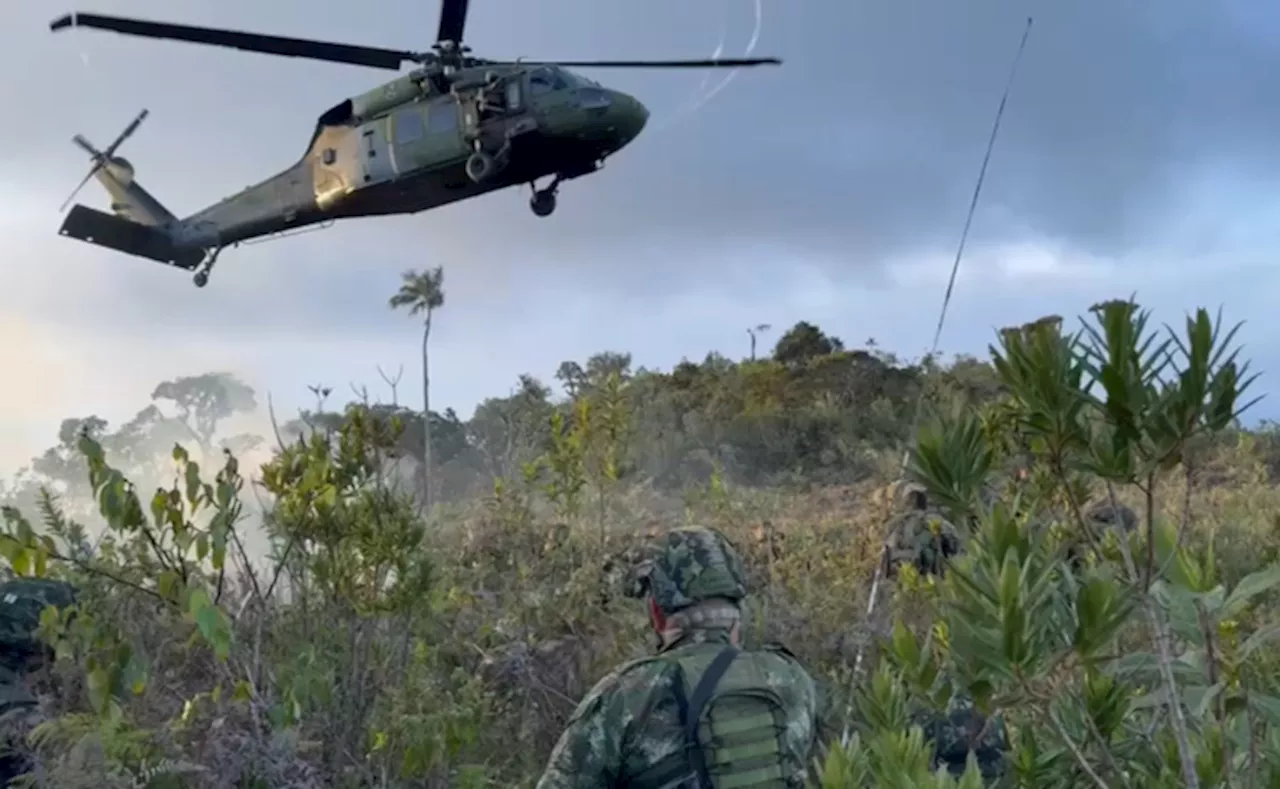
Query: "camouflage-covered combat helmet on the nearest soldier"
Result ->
[[630, 526, 746, 614]]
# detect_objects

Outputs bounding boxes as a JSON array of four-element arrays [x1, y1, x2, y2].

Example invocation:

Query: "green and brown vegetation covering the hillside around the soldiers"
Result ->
[[0, 290, 1280, 789]]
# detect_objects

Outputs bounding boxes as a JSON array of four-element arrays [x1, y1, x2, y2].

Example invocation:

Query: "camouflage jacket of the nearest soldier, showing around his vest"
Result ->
[[536, 630, 818, 789]]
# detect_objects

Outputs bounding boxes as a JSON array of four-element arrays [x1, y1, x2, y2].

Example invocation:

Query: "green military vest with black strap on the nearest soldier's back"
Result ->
[[623, 643, 804, 789]]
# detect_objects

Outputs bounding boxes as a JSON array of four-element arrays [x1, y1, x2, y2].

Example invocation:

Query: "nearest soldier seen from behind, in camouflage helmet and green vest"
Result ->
[[538, 528, 818, 789]]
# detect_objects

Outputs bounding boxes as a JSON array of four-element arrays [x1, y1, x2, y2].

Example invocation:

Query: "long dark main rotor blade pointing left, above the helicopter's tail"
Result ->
[[49, 12, 422, 72]]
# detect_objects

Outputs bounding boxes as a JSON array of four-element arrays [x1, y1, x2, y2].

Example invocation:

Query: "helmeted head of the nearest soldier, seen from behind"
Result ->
[[628, 526, 746, 643]]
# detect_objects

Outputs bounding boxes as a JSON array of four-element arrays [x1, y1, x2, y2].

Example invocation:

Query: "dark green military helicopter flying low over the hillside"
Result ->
[[50, 0, 782, 287]]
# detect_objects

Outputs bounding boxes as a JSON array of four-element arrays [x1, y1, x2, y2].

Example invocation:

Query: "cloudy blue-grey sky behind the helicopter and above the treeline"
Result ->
[[0, 0, 1280, 474]]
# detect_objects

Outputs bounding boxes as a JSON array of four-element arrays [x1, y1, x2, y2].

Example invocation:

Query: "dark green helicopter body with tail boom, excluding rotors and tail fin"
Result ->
[[173, 65, 648, 248]]
